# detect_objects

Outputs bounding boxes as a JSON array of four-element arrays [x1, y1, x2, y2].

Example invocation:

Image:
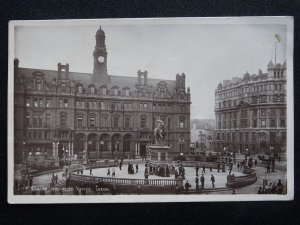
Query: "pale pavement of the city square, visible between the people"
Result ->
[[15, 157, 287, 195]]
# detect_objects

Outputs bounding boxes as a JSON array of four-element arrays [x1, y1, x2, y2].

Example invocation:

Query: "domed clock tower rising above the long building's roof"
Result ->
[[93, 26, 109, 84]]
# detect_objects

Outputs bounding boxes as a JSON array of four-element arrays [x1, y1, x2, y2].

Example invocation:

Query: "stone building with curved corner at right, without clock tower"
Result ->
[[214, 61, 286, 153]]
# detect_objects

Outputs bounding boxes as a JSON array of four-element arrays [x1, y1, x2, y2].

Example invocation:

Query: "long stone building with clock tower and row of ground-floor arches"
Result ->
[[14, 27, 191, 161]]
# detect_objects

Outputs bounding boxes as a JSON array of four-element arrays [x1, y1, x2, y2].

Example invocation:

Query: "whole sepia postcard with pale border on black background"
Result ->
[[7, 17, 294, 204]]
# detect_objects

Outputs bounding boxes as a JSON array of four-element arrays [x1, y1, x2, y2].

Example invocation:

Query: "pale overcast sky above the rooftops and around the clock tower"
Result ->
[[15, 18, 287, 119]]
